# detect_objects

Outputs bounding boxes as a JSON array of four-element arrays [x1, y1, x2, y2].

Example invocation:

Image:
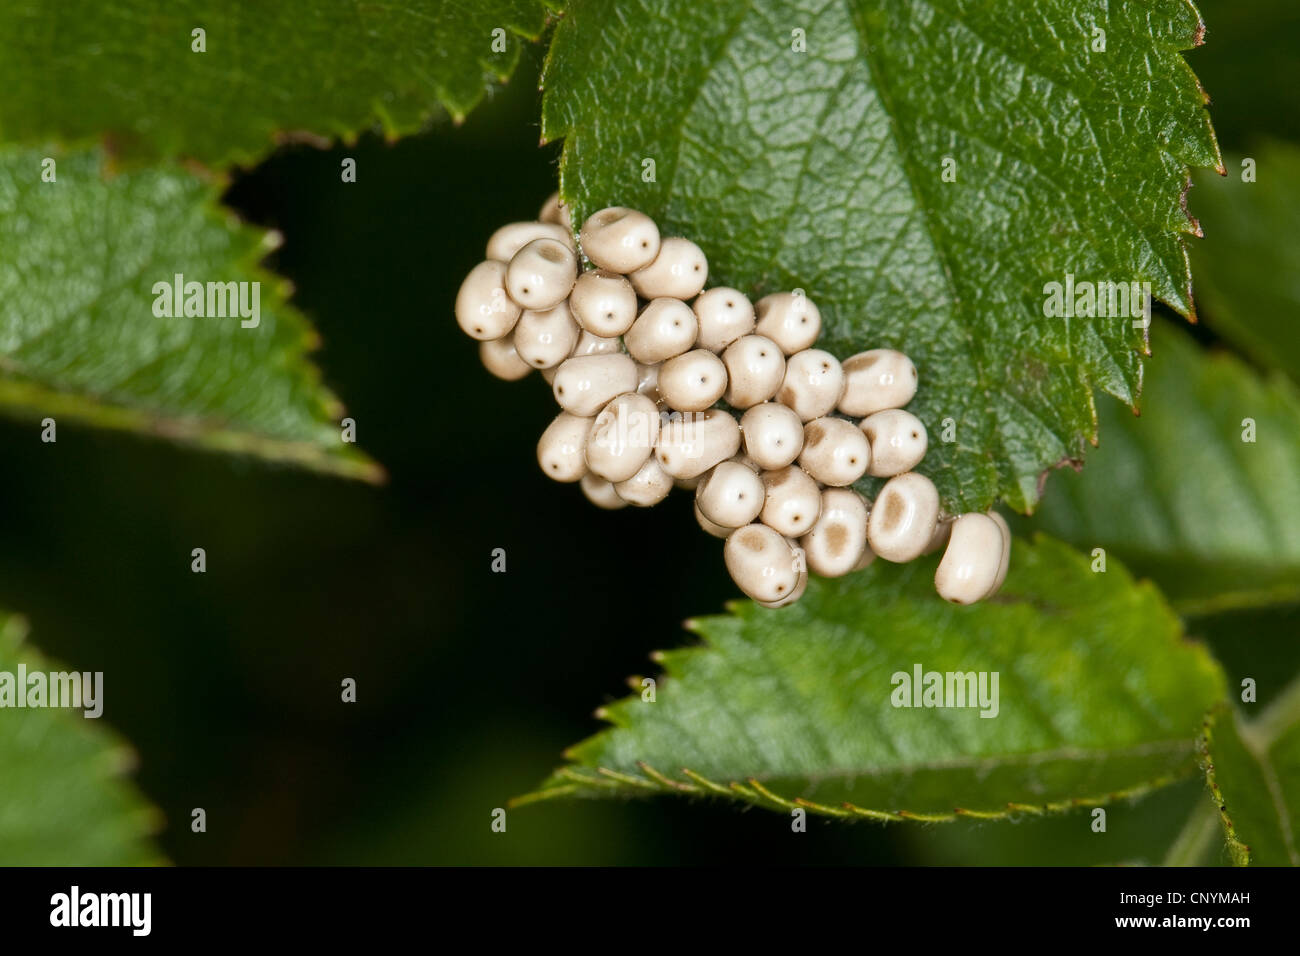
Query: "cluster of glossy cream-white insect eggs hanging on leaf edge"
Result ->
[[455, 195, 1010, 607]]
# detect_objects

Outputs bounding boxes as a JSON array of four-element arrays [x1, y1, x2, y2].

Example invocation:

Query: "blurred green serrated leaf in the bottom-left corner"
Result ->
[[0, 613, 163, 866]]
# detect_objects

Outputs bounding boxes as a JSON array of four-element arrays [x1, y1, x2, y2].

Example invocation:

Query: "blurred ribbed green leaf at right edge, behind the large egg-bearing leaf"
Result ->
[[1034, 323, 1300, 614]]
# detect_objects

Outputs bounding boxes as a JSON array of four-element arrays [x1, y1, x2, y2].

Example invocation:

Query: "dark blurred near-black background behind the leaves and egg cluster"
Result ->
[[0, 4, 1284, 864]]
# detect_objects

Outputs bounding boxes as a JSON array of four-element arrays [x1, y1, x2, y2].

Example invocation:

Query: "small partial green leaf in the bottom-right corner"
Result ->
[[1203, 680, 1300, 866]]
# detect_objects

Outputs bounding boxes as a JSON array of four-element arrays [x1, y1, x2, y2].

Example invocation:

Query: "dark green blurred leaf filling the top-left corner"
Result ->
[[0, 0, 553, 165]]
